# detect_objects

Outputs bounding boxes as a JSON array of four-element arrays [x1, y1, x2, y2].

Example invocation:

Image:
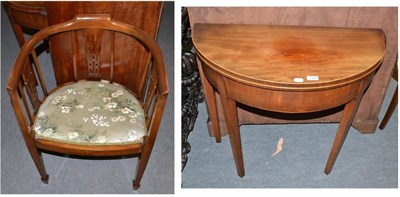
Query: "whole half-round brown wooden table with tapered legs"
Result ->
[[192, 24, 386, 177]]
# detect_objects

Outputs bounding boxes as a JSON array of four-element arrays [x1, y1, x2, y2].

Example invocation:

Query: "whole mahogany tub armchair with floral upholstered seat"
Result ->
[[7, 15, 168, 189]]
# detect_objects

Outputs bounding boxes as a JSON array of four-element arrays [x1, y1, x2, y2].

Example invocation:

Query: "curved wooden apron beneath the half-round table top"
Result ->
[[202, 62, 373, 113]]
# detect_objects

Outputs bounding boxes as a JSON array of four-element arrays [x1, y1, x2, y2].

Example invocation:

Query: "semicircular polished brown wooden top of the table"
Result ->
[[192, 23, 386, 91]]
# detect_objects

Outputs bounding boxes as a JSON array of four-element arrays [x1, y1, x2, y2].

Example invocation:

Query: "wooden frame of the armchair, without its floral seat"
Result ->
[[7, 14, 168, 189]]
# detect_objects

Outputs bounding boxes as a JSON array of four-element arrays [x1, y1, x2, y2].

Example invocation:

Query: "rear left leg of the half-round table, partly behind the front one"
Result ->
[[199, 63, 221, 143]]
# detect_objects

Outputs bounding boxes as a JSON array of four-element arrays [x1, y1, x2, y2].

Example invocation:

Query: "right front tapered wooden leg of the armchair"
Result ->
[[133, 137, 153, 190]]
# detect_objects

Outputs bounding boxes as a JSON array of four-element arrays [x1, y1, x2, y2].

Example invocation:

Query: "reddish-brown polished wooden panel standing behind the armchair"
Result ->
[[45, 1, 163, 99]]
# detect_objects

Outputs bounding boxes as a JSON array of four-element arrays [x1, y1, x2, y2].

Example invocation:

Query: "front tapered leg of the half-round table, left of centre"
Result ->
[[221, 94, 244, 177]]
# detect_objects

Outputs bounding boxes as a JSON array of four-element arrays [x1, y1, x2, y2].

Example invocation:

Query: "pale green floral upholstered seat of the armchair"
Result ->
[[33, 81, 147, 145]]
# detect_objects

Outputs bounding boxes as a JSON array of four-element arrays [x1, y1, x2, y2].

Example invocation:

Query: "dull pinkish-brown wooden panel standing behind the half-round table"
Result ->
[[188, 7, 398, 135]]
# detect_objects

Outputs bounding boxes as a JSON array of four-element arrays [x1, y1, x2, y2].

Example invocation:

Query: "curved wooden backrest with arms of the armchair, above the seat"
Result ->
[[7, 14, 168, 133]]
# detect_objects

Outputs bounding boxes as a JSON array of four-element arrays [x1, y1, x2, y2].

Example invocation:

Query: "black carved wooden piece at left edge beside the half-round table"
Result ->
[[181, 8, 204, 170]]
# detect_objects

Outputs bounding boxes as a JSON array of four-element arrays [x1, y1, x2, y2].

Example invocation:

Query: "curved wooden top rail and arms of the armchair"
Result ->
[[7, 14, 168, 148]]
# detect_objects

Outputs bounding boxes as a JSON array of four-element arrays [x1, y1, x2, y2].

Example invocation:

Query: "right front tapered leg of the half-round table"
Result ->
[[324, 96, 361, 174]]
